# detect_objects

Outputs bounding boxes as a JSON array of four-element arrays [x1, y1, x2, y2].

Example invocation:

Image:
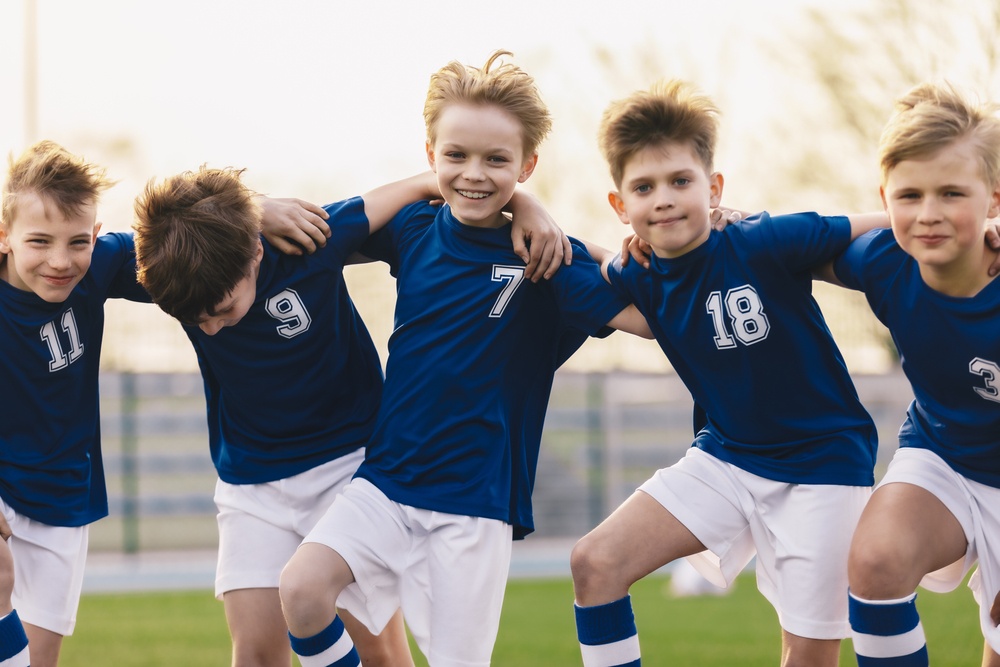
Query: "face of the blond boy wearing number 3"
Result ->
[[881, 139, 1000, 286]]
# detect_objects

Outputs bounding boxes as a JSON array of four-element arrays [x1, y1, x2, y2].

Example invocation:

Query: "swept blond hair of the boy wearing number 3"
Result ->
[[879, 83, 1000, 188]]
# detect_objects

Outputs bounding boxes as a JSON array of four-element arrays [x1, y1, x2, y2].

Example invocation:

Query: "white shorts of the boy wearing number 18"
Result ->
[[639, 447, 871, 639]]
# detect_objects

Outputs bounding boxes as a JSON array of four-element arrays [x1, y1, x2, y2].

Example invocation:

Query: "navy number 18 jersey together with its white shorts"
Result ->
[[608, 213, 876, 639]]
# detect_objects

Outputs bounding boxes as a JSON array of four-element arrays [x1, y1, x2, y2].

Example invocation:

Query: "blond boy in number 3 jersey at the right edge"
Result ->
[[834, 84, 1000, 667]]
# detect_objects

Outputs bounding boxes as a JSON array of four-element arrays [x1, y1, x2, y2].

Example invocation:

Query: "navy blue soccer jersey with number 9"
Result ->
[[184, 197, 382, 484]]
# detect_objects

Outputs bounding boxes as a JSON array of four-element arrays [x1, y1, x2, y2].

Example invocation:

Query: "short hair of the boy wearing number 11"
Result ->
[[0, 140, 114, 227]]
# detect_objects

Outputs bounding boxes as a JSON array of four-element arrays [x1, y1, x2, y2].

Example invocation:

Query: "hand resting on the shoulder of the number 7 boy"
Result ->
[[508, 191, 573, 283]]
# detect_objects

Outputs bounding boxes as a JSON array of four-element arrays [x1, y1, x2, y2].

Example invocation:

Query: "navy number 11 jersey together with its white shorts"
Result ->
[[0, 233, 149, 635]]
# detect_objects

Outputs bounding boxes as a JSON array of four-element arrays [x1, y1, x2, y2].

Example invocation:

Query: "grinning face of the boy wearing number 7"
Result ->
[[427, 104, 538, 227]]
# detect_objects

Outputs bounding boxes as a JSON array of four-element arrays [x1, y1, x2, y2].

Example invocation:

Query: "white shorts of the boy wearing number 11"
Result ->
[[0, 500, 90, 636]]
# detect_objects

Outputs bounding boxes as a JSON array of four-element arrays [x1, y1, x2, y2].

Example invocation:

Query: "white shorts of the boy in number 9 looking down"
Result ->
[[215, 448, 365, 598]]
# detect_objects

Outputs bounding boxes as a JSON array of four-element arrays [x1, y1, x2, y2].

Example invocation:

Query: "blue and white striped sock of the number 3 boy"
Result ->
[[848, 593, 930, 667]]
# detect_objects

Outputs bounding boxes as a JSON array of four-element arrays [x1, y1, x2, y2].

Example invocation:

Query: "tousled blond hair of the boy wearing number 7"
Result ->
[[424, 51, 552, 157]]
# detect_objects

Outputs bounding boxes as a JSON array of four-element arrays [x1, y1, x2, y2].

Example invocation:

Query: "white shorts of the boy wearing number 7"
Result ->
[[304, 479, 512, 667]]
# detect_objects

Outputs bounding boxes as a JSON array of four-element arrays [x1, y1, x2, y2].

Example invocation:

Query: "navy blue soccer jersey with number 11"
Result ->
[[0, 233, 149, 526]]
